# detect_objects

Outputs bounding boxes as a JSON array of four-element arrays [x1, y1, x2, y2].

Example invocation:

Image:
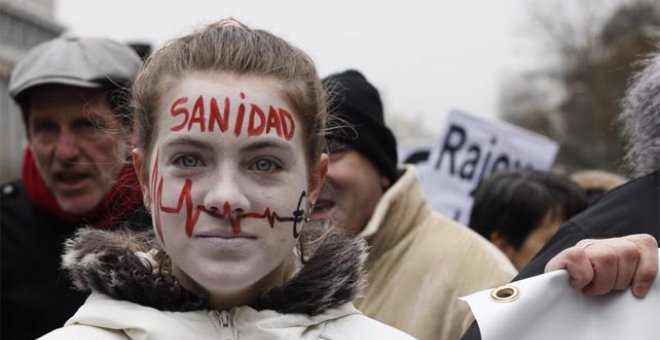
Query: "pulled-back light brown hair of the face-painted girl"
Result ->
[[133, 18, 327, 183]]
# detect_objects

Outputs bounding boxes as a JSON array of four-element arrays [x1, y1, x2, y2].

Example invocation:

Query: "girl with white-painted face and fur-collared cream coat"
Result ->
[[38, 20, 410, 340]]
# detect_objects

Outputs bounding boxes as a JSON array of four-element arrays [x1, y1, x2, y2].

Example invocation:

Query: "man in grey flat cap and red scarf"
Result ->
[[0, 37, 151, 339]]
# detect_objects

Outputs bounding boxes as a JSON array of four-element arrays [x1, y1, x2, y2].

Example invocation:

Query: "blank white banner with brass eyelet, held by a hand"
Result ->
[[461, 250, 660, 340]]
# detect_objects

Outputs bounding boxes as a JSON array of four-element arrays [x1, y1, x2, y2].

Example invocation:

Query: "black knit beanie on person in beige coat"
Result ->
[[323, 70, 399, 183]]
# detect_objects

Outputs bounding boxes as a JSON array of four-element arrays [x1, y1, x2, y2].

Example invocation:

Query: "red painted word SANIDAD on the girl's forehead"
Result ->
[[170, 92, 296, 140]]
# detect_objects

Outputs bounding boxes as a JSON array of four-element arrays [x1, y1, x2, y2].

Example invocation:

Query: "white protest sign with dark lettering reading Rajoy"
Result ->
[[420, 111, 559, 224]]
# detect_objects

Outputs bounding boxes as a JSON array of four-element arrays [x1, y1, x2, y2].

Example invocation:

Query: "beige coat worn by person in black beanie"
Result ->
[[354, 166, 516, 340]]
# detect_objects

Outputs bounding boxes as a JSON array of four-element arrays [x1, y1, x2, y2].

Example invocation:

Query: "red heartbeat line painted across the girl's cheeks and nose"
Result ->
[[152, 151, 305, 242]]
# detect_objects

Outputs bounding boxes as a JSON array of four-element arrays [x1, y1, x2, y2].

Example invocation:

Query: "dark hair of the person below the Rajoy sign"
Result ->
[[469, 170, 587, 249]]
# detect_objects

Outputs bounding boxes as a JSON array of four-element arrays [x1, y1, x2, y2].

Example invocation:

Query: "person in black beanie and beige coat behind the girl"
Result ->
[[310, 70, 516, 339]]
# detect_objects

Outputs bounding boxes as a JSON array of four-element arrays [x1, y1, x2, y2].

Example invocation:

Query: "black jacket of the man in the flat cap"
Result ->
[[0, 180, 151, 339]]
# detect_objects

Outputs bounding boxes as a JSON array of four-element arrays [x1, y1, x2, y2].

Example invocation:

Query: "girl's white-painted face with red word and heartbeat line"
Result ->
[[135, 73, 320, 296]]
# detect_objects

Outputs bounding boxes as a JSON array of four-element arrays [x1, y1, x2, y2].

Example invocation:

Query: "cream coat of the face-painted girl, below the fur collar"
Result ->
[[40, 293, 411, 340]]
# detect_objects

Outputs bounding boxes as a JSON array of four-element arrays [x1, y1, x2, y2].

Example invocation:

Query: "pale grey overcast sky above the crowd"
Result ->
[[56, 0, 532, 141]]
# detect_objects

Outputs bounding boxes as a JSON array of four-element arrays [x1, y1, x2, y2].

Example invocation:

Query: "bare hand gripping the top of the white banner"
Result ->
[[545, 234, 658, 298]]
